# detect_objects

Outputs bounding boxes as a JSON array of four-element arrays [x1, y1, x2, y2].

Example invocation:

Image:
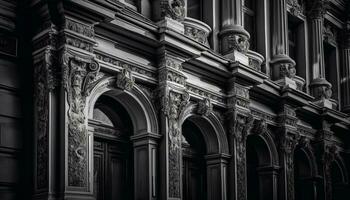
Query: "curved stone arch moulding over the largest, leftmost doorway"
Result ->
[[87, 77, 159, 135]]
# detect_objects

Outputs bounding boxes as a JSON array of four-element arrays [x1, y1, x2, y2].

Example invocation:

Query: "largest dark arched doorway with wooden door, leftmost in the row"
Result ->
[[89, 95, 134, 200]]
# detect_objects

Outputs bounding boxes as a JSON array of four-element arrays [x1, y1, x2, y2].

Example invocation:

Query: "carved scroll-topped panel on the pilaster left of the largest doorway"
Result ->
[[63, 53, 100, 189]]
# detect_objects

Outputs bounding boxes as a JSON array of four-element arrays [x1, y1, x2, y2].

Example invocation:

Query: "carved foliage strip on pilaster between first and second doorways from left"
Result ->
[[162, 90, 190, 198]]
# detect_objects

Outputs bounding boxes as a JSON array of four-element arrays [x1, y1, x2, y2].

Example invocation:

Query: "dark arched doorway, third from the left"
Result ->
[[246, 133, 278, 200]]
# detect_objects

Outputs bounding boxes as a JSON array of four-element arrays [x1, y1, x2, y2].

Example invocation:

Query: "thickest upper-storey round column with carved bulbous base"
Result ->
[[219, 0, 250, 59]]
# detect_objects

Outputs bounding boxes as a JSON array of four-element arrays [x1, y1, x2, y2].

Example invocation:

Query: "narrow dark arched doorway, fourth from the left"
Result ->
[[294, 148, 316, 200]]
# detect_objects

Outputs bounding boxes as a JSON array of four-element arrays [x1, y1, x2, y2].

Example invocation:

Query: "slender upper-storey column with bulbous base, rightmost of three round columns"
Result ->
[[308, 0, 332, 108]]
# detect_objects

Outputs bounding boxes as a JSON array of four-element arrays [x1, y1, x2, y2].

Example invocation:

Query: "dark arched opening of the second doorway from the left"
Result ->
[[182, 120, 207, 200]]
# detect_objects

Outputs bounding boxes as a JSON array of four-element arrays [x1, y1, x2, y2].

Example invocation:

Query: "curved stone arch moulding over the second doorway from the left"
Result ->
[[179, 103, 229, 155]]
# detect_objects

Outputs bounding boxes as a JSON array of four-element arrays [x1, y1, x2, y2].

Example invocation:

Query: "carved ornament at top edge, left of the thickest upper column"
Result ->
[[161, 0, 186, 21]]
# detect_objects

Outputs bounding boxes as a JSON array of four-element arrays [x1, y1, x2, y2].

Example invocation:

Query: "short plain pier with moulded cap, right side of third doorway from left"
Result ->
[[257, 166, 280, 200]]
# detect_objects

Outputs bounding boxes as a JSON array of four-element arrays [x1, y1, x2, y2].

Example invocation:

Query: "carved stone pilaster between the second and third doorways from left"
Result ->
[[227, 79, 254, 200]]
